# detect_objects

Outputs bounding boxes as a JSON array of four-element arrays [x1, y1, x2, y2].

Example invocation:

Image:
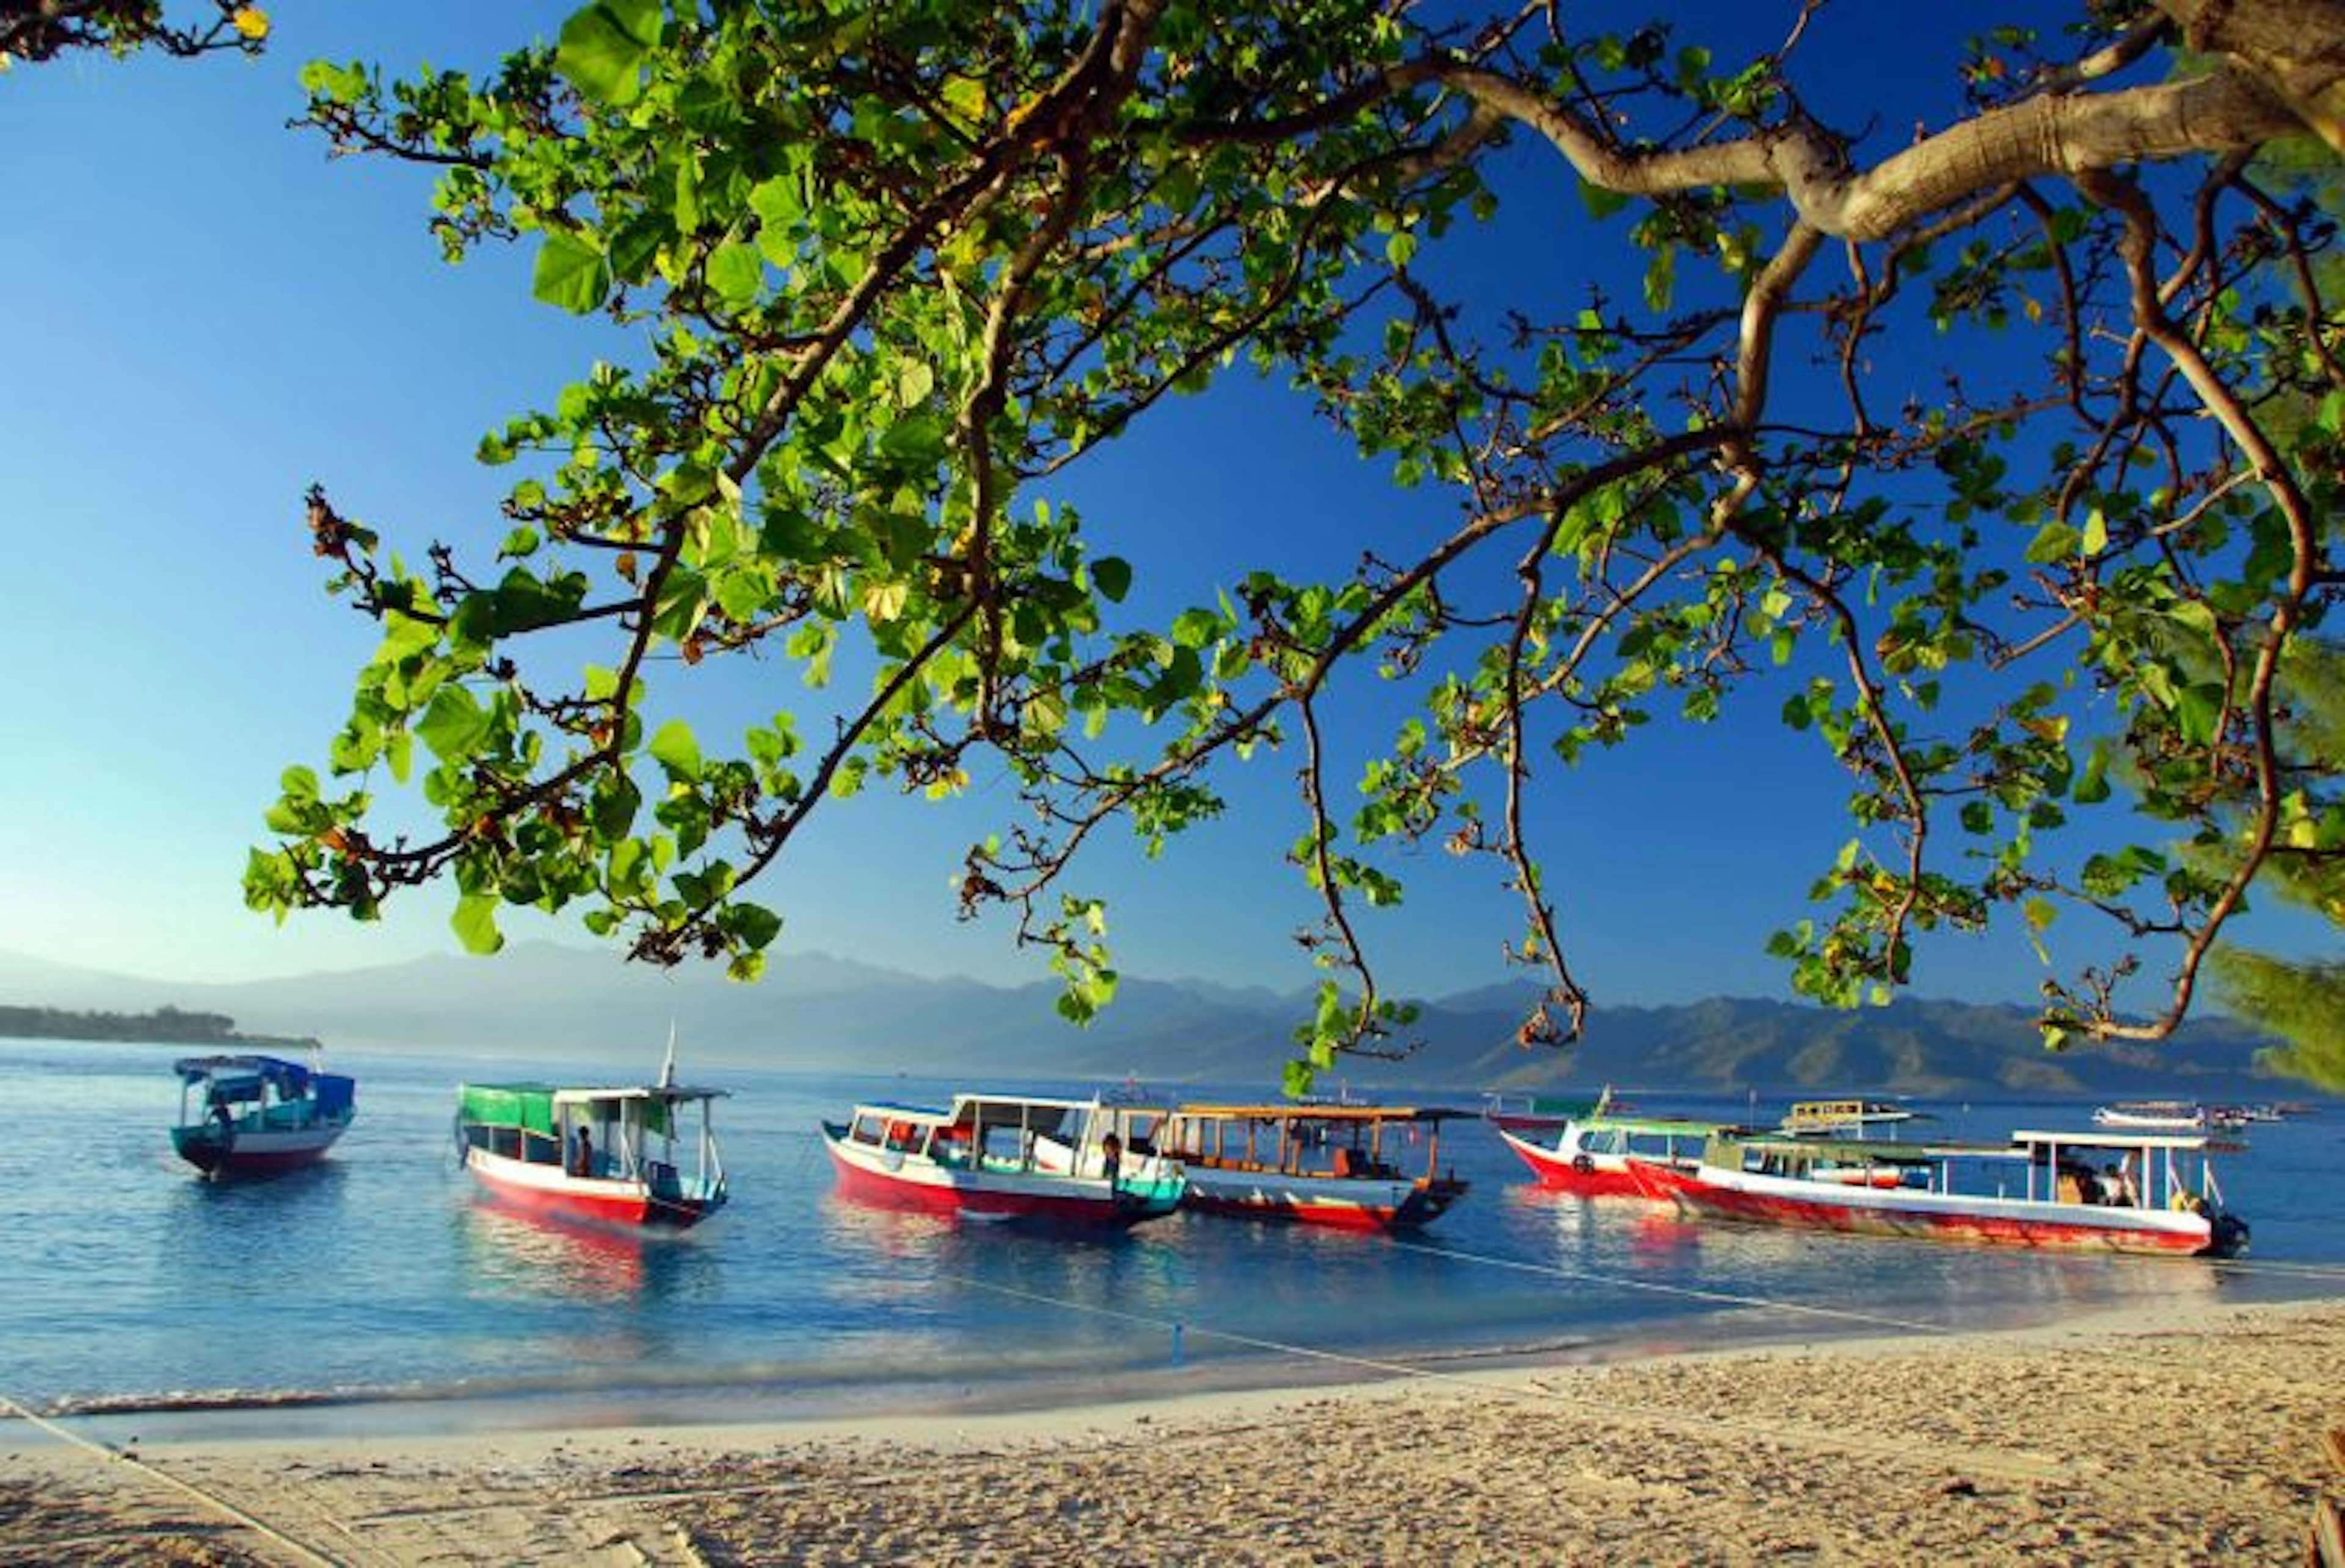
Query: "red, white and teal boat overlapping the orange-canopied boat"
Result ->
[[823, 1095, 1184, 1228]]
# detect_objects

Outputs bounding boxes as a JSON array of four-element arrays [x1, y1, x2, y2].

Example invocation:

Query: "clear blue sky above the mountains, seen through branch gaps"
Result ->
[[0, 0, 2307, 1003]]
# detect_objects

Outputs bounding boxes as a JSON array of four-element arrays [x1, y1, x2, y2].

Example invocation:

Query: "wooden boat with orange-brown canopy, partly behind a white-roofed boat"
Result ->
[[1149, 1104, 1468, 1230]]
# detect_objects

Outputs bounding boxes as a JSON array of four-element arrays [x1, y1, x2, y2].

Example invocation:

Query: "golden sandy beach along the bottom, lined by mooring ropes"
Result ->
[[0, 1301, 2345, 1566]]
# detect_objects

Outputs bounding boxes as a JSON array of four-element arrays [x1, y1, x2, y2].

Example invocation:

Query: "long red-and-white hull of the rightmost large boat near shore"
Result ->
[[1670, 1167, 2223, 1256]]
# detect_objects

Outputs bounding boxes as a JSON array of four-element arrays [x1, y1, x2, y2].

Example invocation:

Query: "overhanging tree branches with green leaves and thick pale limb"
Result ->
[[246, 0, 2345, 1081]]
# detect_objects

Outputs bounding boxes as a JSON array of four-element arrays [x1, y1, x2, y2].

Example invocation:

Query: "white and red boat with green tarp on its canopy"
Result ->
[[455, 1054, 727, 1230]]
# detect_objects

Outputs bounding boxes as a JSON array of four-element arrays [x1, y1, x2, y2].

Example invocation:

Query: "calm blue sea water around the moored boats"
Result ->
[[0, 1038, 2345, 1434]]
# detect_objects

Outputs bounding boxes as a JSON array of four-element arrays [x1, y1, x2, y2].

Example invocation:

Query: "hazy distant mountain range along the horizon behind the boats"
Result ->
[[0, 942, 2286, 1099]]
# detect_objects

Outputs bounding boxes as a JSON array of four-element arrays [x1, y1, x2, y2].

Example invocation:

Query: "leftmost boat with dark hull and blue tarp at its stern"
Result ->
[[171, 1054, 359, 1177]]
